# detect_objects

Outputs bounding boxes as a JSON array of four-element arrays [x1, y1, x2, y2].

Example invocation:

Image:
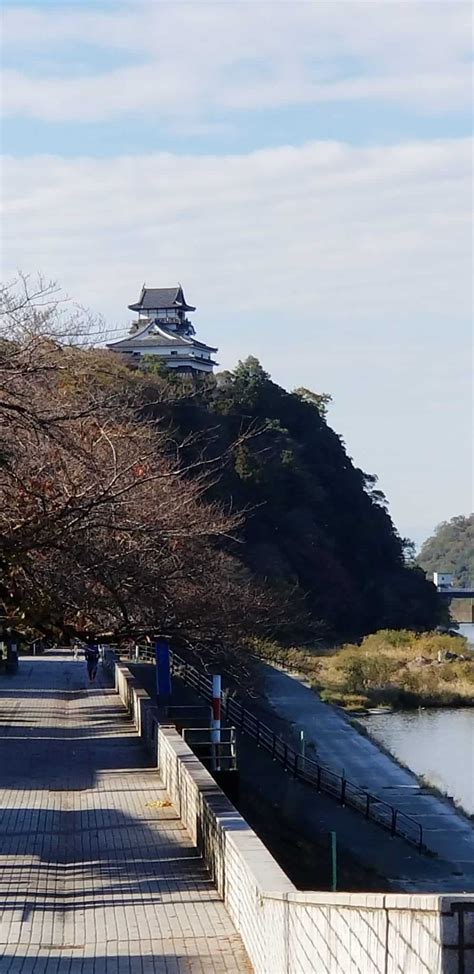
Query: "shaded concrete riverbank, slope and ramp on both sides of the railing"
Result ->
[[130, 658, 474, 893]]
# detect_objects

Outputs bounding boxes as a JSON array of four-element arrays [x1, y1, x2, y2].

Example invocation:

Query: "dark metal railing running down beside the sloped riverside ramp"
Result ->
[[116, 649, 425, 852]]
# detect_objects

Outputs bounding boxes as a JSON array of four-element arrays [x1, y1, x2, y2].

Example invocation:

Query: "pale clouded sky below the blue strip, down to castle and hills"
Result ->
[[2, 132, 471, 533]]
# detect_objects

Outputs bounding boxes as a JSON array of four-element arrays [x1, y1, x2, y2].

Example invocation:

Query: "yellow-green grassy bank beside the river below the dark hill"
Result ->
[[250, 629, 474, 712]]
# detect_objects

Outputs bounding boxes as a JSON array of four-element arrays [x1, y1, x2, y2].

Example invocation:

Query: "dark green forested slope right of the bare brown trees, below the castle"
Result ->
[[145, 358, 444, 638]]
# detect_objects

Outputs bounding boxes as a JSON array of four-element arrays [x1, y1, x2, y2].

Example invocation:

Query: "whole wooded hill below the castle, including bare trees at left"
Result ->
[[0, 322, 442, 647]]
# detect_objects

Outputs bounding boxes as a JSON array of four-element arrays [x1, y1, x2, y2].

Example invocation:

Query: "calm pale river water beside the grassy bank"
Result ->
[[361, 624, 474, 815]]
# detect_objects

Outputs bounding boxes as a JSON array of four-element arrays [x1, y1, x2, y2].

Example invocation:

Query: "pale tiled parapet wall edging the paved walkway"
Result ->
[[104, 658, 474, 974]]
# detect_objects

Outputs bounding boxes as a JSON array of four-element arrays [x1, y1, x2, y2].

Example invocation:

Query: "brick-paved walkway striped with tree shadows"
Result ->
[[0, 651, 251, 974]]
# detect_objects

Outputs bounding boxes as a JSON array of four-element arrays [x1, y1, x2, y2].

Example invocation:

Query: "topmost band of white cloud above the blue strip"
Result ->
[[3, 0, 470, 121]]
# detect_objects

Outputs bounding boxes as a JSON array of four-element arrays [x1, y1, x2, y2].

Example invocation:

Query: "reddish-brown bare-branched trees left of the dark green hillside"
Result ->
[[0, 287, 275, 643]]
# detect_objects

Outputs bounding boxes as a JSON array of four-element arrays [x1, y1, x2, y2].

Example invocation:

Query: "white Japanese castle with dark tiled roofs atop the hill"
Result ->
[[107, 284, 218, 373]]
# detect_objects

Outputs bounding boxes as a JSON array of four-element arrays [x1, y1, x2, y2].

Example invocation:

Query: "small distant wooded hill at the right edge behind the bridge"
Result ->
[[417, 514, 474, 588]]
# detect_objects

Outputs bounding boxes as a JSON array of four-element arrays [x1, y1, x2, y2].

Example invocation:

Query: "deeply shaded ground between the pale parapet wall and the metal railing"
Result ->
[[130, 663, 474, 892]]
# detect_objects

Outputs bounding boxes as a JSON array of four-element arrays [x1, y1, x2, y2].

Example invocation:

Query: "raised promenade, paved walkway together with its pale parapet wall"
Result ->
[[0, 651, 474, 974]]
